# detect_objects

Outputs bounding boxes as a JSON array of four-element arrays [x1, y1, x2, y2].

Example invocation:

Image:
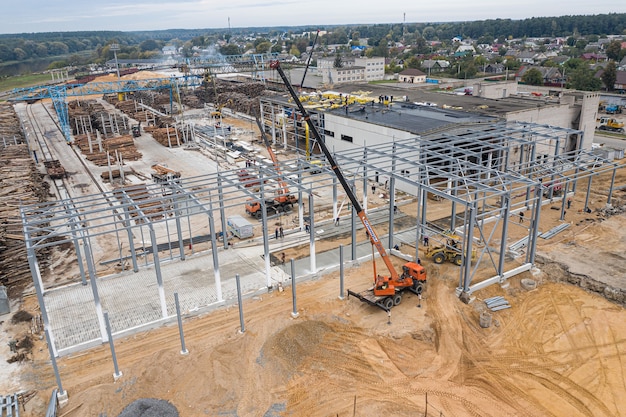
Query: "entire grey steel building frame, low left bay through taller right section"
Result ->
[[21, 114, 623, 354]]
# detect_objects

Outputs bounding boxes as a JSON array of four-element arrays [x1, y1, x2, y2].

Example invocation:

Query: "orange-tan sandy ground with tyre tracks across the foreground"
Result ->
[[0, 83, 626, 417]]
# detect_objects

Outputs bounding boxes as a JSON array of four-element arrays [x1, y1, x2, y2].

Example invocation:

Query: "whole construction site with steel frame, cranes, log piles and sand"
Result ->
[[0, 56, 626, 417]]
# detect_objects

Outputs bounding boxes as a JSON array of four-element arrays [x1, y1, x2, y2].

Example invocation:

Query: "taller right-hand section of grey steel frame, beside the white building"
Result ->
[[324, 122, 624, 296]]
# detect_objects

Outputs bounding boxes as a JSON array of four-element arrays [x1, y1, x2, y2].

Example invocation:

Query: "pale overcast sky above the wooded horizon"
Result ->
[[0, 0, 626, 33]]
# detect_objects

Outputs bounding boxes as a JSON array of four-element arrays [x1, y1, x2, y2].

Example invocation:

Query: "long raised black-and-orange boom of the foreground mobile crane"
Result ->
[[270, 61, 399, 282]]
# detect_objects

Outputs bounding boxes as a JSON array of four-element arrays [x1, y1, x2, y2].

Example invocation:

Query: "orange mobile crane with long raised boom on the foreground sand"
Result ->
[[270, 61, 426, 311]]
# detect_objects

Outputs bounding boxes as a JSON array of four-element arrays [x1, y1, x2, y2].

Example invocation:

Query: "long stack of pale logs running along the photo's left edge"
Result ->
[[0, 144, 51, 294]]
